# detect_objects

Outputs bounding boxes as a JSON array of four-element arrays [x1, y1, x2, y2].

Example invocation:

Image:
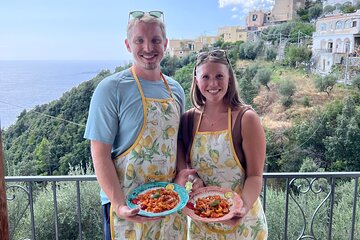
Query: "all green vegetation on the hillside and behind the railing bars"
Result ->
[[3, 20, 360, 239]]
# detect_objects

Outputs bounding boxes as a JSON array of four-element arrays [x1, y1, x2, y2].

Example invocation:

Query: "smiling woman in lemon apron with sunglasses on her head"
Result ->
[[177, 50, 267, 239]]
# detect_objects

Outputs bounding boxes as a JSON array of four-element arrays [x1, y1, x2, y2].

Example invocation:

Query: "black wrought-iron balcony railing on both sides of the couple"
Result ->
[[5, 172, 360, 240]]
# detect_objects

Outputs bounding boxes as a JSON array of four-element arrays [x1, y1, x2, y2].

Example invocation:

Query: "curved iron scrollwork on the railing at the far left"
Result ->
[[6, 185, 30, 239]]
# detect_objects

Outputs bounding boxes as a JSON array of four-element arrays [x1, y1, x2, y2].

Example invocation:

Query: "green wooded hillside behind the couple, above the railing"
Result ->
[[3, 51, 360, 175]]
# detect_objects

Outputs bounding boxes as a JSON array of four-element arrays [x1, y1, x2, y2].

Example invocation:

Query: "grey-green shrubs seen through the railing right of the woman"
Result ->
[[265, 178, 360, 240]]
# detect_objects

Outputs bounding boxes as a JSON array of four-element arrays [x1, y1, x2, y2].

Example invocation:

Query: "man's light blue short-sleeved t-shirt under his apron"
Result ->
[[84, 69, 185, 204]]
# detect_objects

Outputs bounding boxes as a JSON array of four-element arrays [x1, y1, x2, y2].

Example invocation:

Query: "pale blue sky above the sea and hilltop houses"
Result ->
[[0, 0, 274, 60]]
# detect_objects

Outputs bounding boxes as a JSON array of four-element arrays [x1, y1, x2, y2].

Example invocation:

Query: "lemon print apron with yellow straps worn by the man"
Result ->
[[110, 67, 187, 240]]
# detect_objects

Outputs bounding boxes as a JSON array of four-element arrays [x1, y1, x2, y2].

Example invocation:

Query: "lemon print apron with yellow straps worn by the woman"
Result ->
[[190, 108, 267, 240]]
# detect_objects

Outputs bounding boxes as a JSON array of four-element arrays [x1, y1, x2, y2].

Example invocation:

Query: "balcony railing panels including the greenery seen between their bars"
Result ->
[[5, 172, 360, 240]]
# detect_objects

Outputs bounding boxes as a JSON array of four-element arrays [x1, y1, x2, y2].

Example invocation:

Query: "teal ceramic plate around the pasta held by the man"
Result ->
[[126, 182, 189, 217]]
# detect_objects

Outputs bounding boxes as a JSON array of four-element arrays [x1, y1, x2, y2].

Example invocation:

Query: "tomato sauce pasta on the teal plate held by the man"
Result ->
[[137, 188, 180, 213]]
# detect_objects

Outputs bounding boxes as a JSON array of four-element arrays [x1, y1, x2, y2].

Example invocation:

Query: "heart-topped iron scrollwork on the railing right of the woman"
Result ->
[[288, 177, 332, 240]]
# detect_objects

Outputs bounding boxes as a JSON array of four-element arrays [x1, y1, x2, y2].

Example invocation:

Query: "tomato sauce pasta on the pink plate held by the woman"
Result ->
[[194, 195, 230, 218]]
